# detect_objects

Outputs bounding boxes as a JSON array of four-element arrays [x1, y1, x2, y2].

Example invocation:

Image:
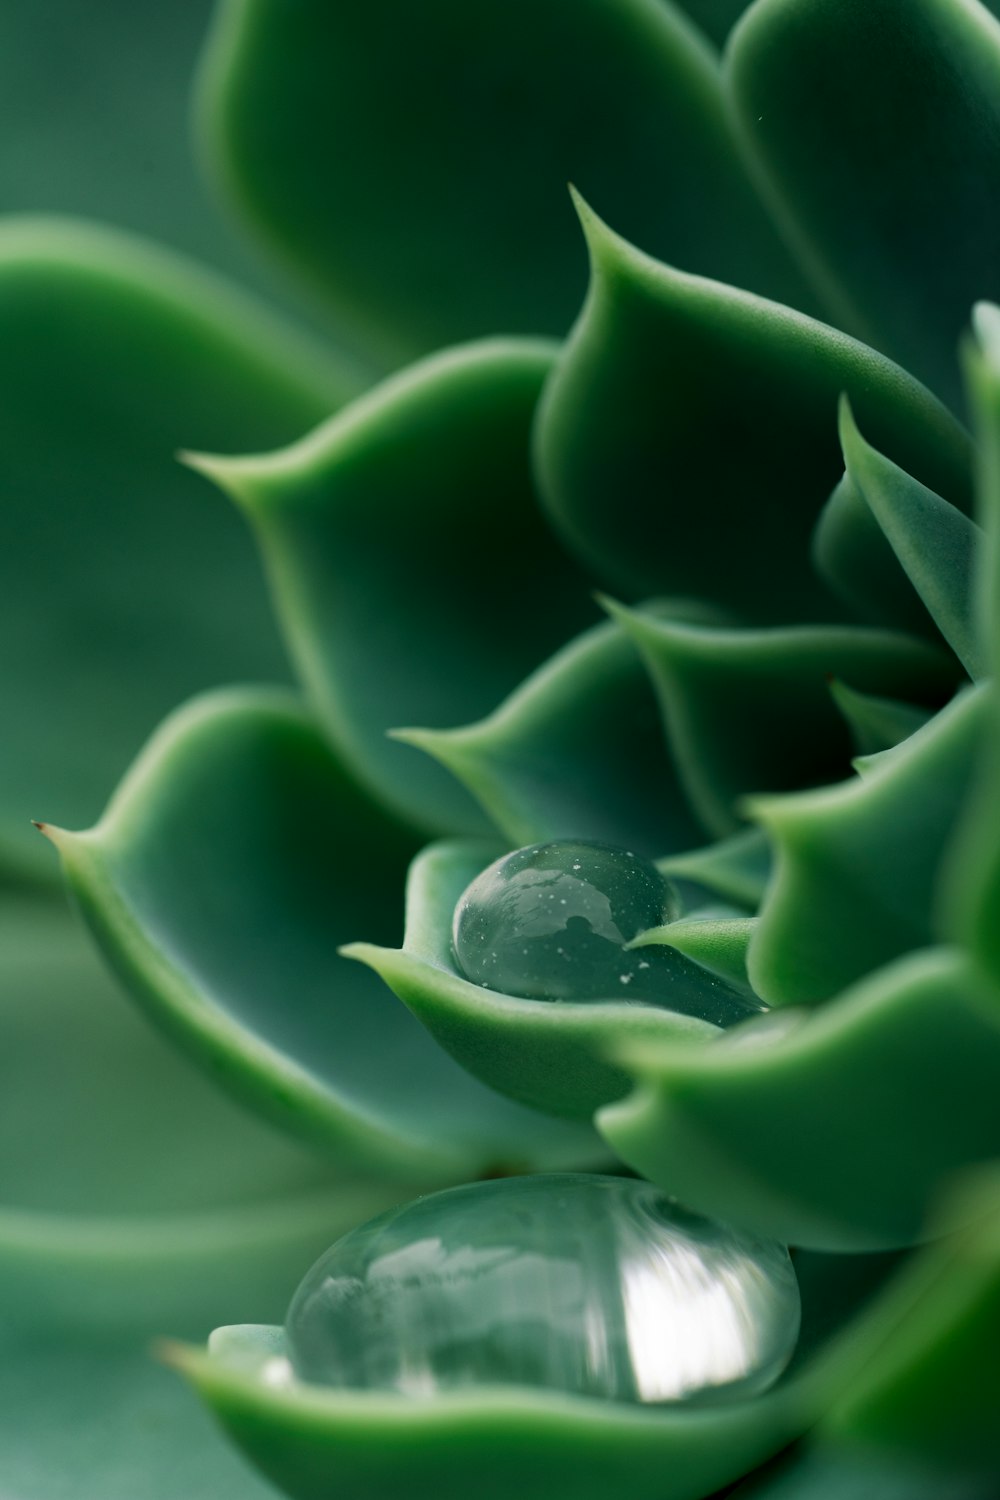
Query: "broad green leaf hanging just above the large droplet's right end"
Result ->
[[597, 950, 1000, 1251]]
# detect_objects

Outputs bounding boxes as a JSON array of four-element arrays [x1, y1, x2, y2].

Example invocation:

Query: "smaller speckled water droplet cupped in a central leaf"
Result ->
[[451, 840, 762, 1026]]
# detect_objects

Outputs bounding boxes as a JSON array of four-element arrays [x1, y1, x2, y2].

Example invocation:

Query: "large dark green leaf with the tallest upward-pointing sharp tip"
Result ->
[[535, 209, 969, 623]]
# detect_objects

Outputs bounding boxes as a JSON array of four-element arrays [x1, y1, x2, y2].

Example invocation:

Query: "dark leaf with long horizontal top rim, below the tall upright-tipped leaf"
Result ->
[[610, 605, 957, 836]]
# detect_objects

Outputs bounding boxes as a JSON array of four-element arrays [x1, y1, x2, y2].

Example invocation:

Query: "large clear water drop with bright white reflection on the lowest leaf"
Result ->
[[286, 1175, 799, 1403]]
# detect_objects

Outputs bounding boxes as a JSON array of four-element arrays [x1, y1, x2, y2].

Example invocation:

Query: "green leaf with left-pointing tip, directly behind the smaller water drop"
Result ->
[[397, 624, 700, 857]]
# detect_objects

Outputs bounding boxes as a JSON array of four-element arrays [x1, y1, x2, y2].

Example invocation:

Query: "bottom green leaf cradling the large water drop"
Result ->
[[169, 1328, 805, 1500]]
